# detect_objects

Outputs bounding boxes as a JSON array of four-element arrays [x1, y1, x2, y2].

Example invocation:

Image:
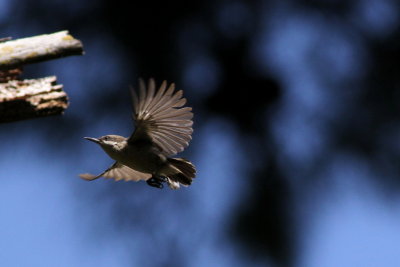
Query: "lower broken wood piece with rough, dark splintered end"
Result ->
[[0, 76, 68, 123]]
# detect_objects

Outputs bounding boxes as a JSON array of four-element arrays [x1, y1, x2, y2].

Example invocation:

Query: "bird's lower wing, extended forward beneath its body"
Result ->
[[79, 162, 151, 182]]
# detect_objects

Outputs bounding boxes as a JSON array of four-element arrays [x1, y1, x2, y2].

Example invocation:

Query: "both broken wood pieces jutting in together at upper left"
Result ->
[[0, 31, 84, 123]]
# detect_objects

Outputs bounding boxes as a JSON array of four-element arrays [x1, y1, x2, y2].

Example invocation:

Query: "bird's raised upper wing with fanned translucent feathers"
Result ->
[[128, 79, 193, 156]]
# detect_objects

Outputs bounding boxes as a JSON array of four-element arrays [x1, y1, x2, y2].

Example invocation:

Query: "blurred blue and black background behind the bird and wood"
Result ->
[[0, 0, 400, 267]]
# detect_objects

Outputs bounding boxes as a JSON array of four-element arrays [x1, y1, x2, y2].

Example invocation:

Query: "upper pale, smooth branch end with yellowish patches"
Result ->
[[0, 31, 83, 70]]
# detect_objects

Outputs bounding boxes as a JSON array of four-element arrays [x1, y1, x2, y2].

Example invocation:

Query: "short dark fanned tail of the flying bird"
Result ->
[[168, 158, 196, 189]]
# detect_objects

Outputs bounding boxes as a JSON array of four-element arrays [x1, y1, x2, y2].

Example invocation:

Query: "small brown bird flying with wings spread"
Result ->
[[79, 78, 196, 189]]
